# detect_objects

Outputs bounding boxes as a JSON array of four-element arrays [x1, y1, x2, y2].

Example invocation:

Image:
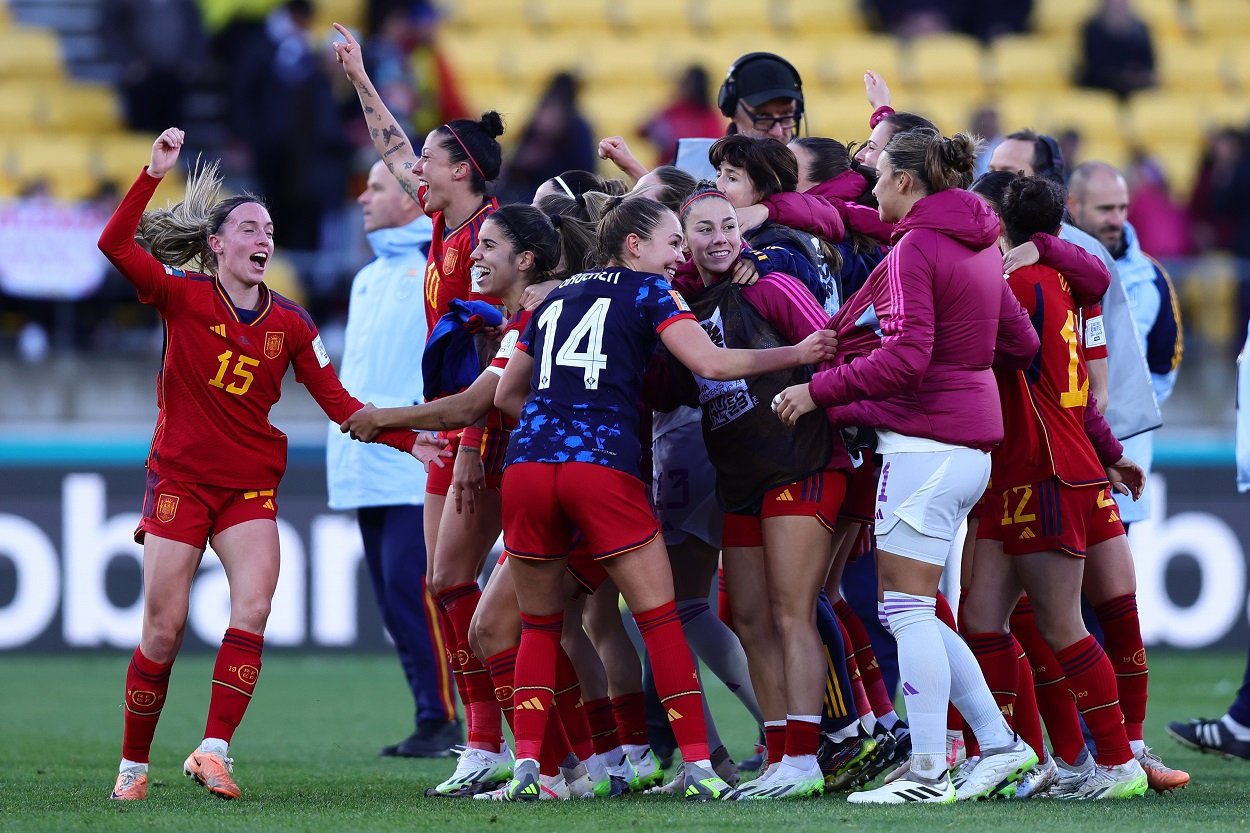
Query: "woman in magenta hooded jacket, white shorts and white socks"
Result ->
[[776, 130, 1038, 803]]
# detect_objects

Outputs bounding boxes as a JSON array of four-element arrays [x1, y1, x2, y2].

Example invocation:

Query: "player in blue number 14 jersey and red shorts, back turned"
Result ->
[[495, 196, 833, 800]]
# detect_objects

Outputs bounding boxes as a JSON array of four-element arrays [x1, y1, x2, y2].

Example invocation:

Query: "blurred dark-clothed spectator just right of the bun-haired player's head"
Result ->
[[504, 73, 595, 203]]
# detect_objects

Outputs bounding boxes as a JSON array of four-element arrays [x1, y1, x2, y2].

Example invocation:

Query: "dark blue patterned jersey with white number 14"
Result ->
[[508, 269, 695, 477]]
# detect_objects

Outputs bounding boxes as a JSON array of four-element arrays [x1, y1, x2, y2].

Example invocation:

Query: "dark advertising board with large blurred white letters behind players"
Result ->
[[0, 455, 1250, 650]]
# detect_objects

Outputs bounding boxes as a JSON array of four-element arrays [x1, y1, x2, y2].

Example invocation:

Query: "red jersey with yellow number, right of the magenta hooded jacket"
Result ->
[[990, 265, 1106, 489]]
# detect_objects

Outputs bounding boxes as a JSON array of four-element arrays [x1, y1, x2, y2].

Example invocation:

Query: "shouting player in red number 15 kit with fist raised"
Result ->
[[100, 128, 436, 800]]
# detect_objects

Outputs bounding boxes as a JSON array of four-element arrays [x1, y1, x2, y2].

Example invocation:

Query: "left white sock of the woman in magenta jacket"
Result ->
[[881, 590, 950, 778]]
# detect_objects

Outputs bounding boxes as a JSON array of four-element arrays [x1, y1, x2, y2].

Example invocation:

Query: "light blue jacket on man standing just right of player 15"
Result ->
[[326, 216, 434, 509]]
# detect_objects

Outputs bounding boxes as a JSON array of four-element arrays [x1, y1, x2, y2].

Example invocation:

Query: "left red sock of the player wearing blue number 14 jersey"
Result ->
[[513, 610, 564, 760]]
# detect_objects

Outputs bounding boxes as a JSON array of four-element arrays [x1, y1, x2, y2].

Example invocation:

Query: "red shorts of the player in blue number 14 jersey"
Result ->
[[503, 463, 660, 560]]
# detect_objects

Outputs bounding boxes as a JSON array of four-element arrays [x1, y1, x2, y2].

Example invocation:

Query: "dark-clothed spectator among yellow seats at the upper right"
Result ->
[[1078, 0, 1155, 98]]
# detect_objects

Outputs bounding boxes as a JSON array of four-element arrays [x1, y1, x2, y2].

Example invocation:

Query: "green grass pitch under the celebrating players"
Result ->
[[0, 652, 1250, 833]]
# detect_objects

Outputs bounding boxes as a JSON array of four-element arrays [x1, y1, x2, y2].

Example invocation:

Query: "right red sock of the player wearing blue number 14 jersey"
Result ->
[[634, 600, 711, 762]]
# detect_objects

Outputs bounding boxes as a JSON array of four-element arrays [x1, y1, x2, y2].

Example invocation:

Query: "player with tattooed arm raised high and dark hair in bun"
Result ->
[[334, 24, 506, 749]]
